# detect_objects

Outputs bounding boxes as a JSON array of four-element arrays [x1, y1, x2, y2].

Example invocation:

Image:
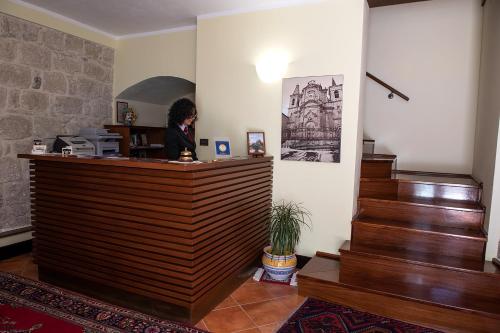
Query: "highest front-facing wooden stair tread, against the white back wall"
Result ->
[[392, 170, 480, 188]]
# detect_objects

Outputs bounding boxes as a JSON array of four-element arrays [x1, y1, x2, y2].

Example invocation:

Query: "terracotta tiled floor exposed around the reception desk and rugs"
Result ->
[[0, 254, 305, 333]]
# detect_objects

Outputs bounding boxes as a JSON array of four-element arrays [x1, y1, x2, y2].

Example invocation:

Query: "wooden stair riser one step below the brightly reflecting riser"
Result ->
[[359, 199, 483, 229]]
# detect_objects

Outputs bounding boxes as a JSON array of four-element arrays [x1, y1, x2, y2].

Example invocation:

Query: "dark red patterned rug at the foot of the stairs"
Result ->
[[278, 298, 441, 333]]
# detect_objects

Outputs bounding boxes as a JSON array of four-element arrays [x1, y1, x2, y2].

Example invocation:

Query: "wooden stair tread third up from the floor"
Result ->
[[353, 216, 487, 242]]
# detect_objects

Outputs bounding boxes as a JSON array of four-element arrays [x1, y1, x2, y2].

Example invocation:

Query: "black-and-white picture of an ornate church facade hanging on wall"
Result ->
[[281, 75, 344, 163]]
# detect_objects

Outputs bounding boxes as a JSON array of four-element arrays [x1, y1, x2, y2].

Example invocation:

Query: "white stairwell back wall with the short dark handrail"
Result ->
[[364, 0, 482, 174]]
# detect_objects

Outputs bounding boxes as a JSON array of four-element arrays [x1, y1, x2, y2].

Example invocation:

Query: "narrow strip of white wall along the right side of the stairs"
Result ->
[[472, 0, 500, 259]]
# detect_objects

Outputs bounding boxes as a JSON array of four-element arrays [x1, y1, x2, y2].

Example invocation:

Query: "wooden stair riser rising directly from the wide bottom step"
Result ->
[[339, 252, 500, 304]]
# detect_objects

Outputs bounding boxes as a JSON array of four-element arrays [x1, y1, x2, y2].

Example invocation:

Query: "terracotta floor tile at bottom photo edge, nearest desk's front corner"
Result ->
[[203, 306, 256, 333]]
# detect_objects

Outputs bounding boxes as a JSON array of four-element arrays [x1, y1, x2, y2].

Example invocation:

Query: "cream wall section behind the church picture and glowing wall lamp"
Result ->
[[196, 0, 367, 255]]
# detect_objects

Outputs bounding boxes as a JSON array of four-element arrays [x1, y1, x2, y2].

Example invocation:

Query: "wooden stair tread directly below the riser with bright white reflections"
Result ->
[[359, 195, 484, 212]]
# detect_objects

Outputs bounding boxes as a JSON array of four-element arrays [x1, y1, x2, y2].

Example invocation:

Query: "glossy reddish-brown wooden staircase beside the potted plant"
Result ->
[[298, 155, 500, 333]]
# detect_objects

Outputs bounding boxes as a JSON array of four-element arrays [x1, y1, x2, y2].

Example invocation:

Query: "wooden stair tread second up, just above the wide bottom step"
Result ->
[[339, 241, 492, 272]]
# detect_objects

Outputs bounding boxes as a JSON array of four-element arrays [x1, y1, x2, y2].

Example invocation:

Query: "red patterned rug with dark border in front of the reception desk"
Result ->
[[0, 272, 205, 333]]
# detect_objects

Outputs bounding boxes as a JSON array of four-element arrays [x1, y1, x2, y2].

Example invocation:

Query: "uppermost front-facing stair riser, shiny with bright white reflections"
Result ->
[[398, 182, 480, 202]]
